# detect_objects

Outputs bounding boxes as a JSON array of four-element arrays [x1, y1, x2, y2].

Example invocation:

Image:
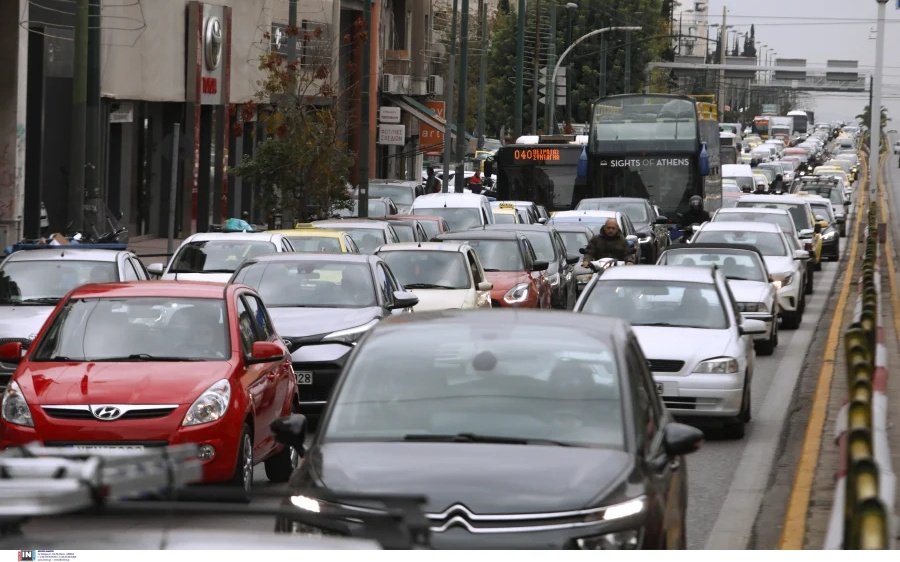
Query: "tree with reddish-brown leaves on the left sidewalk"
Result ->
[[232, 23, 358, 220]]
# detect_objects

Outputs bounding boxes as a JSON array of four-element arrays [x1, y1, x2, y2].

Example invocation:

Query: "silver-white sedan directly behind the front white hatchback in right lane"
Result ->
[[656, 243, 778, 355]]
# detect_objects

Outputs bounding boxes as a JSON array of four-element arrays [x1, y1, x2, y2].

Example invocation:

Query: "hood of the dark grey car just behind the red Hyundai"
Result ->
[[267, 306, 381, 338]]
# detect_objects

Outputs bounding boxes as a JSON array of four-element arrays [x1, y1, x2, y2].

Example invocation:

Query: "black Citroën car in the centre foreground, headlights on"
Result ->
[[273, 309, 703, 550]]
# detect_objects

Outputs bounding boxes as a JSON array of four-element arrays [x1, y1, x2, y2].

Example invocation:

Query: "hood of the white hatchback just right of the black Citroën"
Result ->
[[633, 326, 732, 369]]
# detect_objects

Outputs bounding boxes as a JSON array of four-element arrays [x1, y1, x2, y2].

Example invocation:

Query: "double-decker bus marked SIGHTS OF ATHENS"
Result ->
[[586, 94, 722, 222]]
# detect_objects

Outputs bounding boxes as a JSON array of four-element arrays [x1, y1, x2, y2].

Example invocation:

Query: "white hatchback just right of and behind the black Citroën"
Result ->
[[575, 265, 766, 439]]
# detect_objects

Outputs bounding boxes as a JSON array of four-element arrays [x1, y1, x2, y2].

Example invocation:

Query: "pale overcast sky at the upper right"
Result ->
[[708, 0, 900, 129]]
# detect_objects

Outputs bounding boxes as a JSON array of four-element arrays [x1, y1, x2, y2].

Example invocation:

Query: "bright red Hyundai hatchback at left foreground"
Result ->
[[0, 281, 297, 499]]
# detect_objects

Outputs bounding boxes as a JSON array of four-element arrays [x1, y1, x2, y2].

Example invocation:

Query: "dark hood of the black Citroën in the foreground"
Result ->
[[300, 442, 634, 514]]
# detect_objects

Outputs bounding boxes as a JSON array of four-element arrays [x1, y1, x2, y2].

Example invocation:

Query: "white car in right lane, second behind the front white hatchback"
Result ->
[[691, 222, 810, 329]]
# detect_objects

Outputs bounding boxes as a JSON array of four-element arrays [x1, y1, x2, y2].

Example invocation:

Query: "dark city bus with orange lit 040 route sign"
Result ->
[[494, 135, 588, 211]]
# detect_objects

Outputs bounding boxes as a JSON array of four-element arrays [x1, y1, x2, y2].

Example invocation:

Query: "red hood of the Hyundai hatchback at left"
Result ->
[[16, 361, 232, 405]]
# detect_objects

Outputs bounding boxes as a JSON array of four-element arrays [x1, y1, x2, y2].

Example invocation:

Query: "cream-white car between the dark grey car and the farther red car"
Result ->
[[375, 242, 494, 312]]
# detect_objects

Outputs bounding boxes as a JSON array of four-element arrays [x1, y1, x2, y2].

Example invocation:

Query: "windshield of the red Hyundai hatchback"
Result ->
[[32, 296, 231, 360]]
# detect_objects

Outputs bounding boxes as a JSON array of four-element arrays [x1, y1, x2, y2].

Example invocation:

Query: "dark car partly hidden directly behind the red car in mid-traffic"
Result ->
[[485, 224, 581, 310]]
